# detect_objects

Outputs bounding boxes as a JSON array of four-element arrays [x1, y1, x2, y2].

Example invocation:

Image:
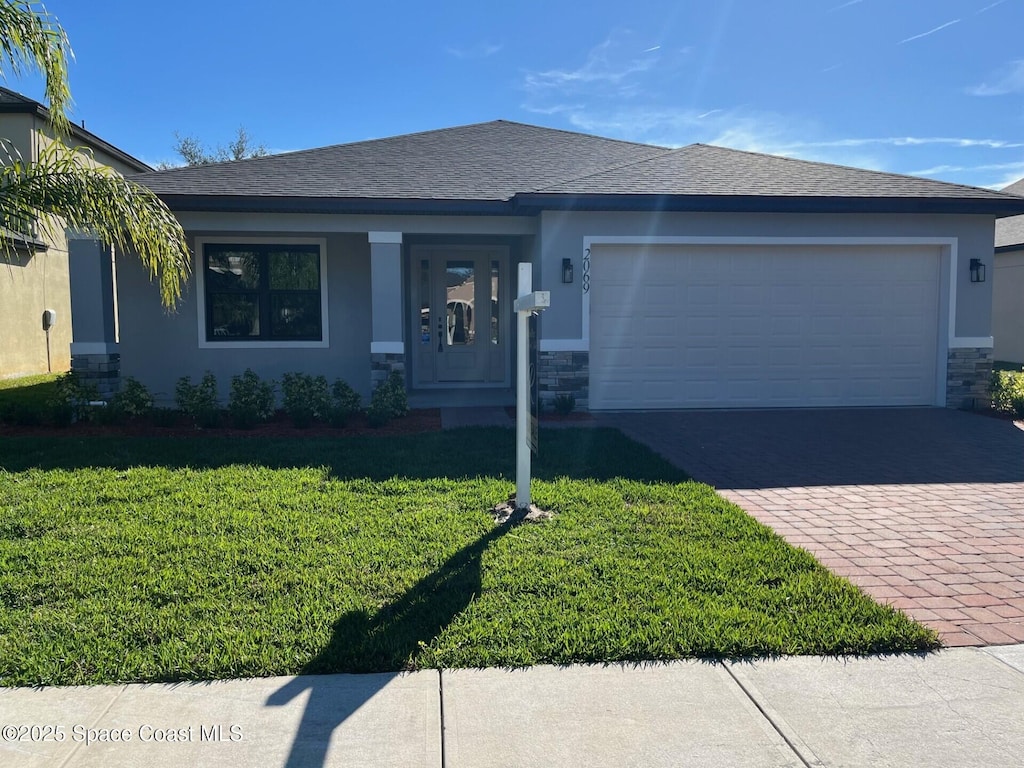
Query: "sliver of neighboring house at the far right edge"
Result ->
[[992, 179, 1024, 366]]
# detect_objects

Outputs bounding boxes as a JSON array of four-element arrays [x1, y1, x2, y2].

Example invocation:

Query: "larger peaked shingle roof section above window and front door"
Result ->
[[134, 120, 668, 201]]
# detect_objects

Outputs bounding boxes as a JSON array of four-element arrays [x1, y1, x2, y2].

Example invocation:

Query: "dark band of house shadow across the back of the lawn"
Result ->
[[0, 427, 686, 482]]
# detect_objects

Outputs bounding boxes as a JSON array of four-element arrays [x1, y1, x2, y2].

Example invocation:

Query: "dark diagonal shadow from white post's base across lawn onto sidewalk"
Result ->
[[266, 513, 523, 768]]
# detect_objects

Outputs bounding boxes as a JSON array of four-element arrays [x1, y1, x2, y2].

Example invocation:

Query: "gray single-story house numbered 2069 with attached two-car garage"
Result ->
[[74, 121, 1024, 410]]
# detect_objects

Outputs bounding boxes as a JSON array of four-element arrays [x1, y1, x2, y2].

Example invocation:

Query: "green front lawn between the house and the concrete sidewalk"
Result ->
[[0, 429, 937, 686]]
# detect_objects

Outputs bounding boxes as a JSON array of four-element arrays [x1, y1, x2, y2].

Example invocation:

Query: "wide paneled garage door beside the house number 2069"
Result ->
[[590, 245, 940, 410]]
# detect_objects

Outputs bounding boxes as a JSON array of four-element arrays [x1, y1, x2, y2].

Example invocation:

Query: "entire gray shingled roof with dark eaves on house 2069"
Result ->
[[133, 120, 1024, 215]]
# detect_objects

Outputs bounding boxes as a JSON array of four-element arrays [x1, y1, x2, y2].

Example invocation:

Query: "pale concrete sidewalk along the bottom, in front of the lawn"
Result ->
[[0, 645, 1024, 768]]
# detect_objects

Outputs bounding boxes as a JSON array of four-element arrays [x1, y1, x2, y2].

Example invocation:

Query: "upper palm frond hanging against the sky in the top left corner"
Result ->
[[0, 0, 74, 133]]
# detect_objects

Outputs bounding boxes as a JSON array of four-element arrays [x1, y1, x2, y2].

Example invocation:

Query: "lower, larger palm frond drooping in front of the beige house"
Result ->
[[0, 142, 191, 308]]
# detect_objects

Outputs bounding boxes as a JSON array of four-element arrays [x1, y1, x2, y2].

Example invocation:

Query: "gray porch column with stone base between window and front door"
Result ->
[[369, 232, 406, 389]]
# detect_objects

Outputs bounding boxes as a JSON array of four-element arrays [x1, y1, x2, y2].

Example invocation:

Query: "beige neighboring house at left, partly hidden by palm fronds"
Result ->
[[0, 103, 149, 379]]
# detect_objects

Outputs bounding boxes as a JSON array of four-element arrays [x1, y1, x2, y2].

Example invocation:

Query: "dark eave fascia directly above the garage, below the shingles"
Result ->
[[514, 193, 1024, 218]]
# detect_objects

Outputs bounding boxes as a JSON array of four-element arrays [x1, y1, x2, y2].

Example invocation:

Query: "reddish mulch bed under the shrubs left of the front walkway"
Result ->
[[0, 409, 441, 438]]
